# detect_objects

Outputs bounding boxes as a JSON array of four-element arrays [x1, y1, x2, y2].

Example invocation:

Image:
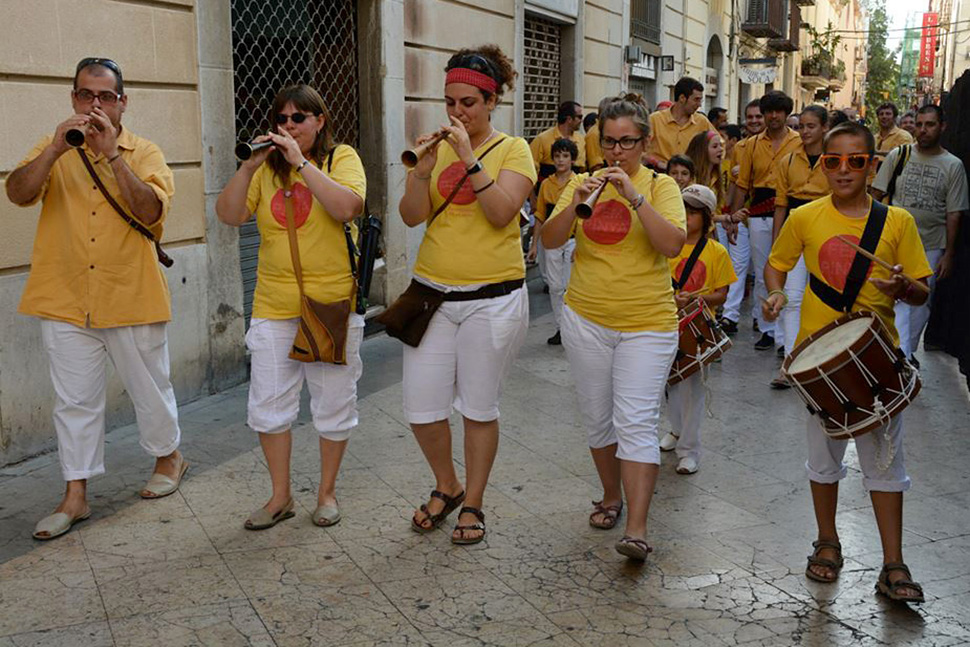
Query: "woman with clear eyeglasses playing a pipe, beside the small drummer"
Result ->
[[542, 99, 686, 560]]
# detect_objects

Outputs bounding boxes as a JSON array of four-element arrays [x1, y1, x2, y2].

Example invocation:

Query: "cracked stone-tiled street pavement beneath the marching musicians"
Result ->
[[0, 286, 970, 647]]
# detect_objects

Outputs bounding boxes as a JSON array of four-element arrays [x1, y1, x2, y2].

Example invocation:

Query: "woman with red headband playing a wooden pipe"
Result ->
[[400, 45, 536, 544]]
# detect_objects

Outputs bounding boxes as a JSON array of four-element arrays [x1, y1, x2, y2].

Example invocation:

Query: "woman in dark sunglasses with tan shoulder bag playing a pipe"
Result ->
[[216, 85, 367, 530]]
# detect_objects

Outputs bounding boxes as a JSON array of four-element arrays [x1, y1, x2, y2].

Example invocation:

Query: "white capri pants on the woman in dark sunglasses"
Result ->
[[246, 313, 364, 442]]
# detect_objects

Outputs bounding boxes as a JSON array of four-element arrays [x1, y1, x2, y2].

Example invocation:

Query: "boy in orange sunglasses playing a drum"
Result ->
[[762, 122, 932, 602]]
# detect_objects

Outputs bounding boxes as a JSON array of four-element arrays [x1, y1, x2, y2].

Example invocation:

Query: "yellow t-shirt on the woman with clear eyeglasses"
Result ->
[[550, 167, 687, 332]]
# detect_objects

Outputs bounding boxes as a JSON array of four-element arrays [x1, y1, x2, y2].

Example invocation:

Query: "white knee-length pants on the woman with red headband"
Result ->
[[403, 287, 529, 424]]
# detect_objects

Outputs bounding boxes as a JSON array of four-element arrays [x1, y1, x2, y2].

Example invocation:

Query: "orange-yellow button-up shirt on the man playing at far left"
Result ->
[[19, 129, 175, 328]]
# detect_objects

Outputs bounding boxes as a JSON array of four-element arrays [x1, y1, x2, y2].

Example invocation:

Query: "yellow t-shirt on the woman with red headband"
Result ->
[[414, 133, 537, 285]]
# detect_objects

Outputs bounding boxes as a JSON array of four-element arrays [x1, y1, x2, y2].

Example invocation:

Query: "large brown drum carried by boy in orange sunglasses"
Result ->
[[781, 312, 920, 439]]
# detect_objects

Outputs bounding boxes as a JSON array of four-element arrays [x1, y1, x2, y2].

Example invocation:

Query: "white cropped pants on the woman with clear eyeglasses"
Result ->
[[562, 306, 678, 465]]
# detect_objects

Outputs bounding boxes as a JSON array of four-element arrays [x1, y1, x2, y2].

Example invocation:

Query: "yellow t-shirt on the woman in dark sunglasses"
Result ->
[[246, 144, 367, 319]]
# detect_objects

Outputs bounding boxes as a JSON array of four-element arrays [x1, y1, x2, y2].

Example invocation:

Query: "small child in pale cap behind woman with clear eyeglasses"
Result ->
[[660, 184, 737, 474]]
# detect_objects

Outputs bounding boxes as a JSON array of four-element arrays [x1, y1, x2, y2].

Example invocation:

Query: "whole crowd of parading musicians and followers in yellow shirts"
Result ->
[[6, 46, 968, 602]]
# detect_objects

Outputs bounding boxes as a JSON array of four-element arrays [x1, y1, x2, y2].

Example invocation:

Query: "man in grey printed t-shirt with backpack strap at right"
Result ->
[[872, 105, 970, 365]]
